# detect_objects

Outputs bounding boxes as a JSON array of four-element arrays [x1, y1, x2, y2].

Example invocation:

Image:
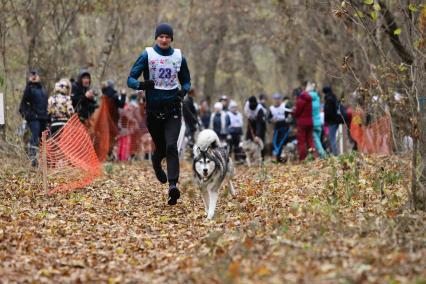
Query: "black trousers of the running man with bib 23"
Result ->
[[147, 114, 182, 184]]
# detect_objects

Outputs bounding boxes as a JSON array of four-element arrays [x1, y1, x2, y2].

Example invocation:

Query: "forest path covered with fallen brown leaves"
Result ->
[[0, 155, 426, 283]]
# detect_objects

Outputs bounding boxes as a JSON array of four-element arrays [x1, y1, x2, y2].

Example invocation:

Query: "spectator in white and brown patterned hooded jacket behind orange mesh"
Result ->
[[47, 79, 74, 135]]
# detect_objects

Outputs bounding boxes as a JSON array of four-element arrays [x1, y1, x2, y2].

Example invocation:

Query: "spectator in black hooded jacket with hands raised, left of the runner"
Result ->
[[71, 70, 97, 122]]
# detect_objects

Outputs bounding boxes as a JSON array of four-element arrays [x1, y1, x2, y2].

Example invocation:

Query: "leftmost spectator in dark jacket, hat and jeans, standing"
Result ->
[[19, 69, 48, 166]]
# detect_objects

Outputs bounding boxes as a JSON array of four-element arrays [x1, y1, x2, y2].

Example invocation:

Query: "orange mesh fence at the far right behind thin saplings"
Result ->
[[351, 110, 392, 155]]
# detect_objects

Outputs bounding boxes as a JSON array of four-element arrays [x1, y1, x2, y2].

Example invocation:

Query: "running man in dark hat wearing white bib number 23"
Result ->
[[127, 23, 191, 205]]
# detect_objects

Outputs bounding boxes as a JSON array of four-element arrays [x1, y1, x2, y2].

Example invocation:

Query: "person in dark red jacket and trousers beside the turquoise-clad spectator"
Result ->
[[293, 87, 315, 161]]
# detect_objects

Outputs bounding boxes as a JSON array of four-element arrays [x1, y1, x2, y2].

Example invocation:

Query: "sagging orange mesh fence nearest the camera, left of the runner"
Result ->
[[39, 115, 102, 194]]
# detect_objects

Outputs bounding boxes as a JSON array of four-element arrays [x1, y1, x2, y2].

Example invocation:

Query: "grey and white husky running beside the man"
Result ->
[[192, 129, 235, 219]]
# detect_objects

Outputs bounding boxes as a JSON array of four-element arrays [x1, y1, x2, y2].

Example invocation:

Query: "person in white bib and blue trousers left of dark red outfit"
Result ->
[[268, 93, 292, 163]]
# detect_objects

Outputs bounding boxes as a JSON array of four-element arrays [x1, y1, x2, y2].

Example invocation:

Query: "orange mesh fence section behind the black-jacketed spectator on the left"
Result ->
[[89, 96, 119, 162]]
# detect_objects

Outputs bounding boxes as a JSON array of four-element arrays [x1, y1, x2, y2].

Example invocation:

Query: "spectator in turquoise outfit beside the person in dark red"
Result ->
[[306, 82, 326, 158]]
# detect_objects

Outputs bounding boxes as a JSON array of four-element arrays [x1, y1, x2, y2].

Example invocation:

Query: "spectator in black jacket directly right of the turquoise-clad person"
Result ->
[[322, 86, 342, 156]]
